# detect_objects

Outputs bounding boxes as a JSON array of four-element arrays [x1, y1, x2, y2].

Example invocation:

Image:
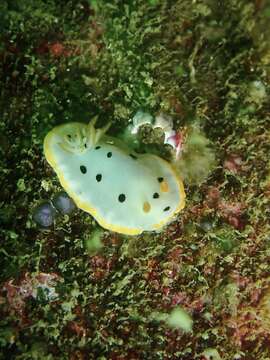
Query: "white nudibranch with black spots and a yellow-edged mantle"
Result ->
[[44, 121, 185, 235]]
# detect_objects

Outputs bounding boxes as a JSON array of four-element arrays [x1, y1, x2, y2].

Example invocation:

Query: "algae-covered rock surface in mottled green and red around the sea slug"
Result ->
[[0, 0, 270, 360]]
